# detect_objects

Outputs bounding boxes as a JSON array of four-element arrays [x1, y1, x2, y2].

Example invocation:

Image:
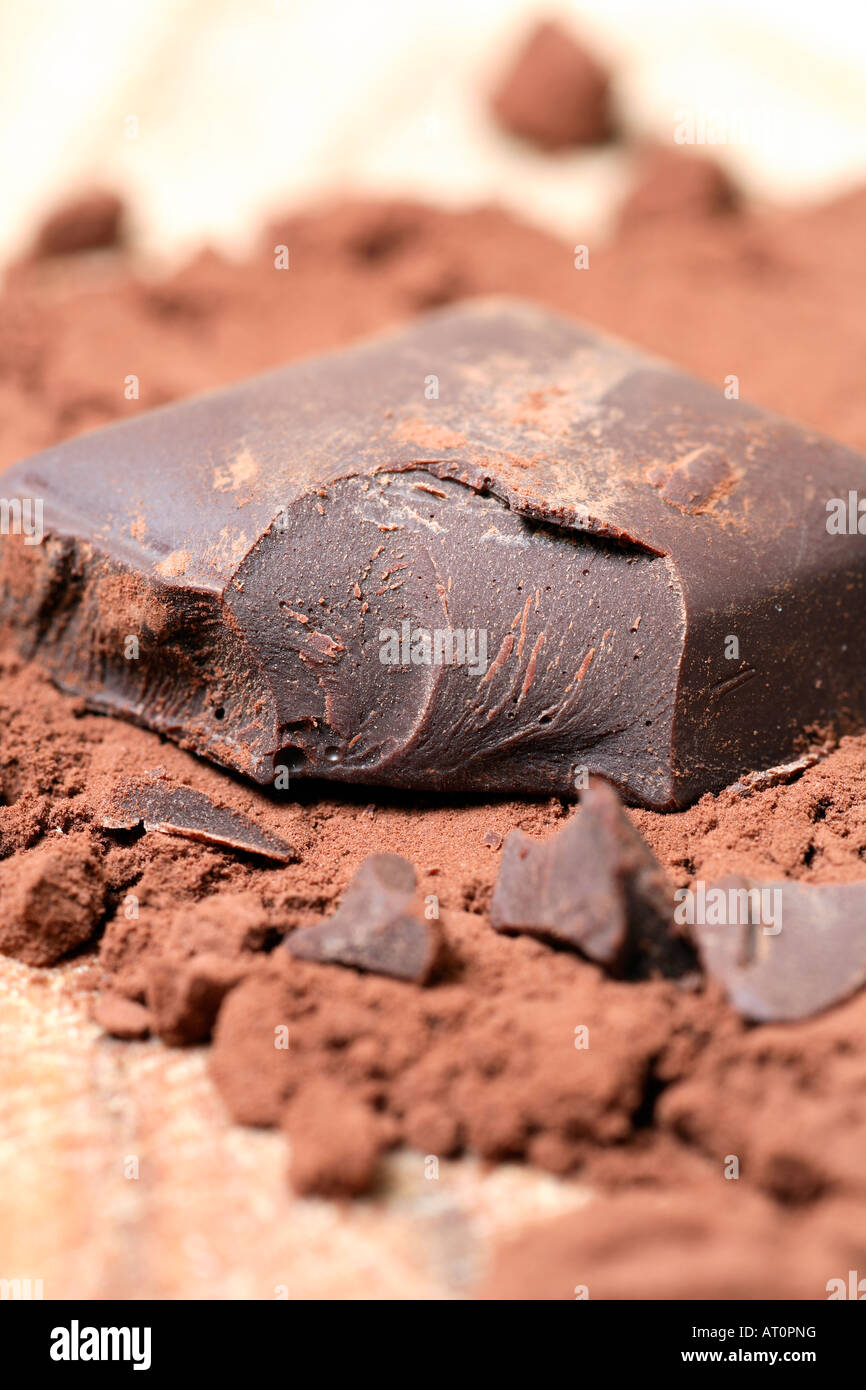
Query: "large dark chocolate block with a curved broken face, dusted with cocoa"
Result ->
[[0, 300, 866, 808]]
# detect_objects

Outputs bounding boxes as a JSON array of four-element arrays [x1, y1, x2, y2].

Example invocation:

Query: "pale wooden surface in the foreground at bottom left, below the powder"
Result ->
[[0, 958, 589, 1300]]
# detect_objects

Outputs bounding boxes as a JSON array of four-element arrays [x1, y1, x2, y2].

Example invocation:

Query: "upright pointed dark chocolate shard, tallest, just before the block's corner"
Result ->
[[491, 783, 691, 974]]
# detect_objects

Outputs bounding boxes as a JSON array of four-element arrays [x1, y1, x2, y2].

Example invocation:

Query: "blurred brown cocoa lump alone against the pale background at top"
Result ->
[[492, 22, 612, 150]]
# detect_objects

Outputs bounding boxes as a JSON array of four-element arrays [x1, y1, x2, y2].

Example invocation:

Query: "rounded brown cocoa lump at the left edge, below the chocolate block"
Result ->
[[0, 833, 106, 965]]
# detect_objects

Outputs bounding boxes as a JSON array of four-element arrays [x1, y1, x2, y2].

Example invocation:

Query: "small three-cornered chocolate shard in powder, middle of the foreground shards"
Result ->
[[286, 855, 441, 984]]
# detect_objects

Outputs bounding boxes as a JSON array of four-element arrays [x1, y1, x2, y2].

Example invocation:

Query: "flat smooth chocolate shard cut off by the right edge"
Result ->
[[694, 876, 866, 1023]]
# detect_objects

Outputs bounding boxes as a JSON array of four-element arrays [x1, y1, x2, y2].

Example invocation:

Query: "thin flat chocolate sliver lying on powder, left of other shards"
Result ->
[[99, 774, 295, 863]]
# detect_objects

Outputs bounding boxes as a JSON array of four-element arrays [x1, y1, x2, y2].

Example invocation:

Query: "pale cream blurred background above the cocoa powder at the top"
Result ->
[[0, 0, 866, 261]]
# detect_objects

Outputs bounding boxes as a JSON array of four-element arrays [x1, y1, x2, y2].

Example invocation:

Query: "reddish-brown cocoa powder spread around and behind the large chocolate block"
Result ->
[[0, 165, 866, 1298]]
